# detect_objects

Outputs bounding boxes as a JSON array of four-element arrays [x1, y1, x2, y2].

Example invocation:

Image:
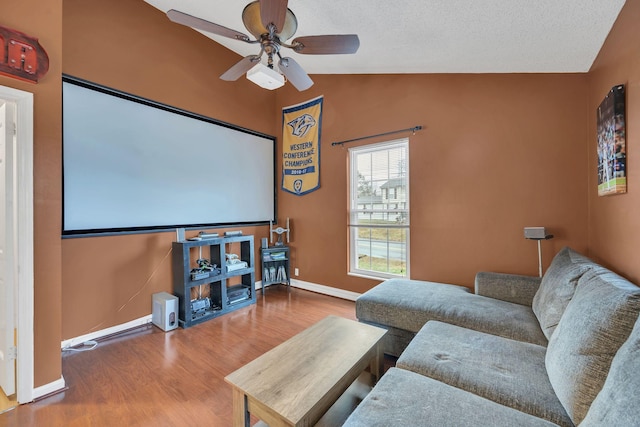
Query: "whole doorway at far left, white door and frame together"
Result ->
[[0, 86, 34, 410]]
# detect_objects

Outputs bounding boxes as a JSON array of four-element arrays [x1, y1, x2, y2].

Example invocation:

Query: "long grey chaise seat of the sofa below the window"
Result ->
[[356, 279, 547, 345]]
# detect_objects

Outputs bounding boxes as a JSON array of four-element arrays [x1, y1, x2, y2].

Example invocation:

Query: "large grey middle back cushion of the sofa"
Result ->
[[546, 267, 640, 424]]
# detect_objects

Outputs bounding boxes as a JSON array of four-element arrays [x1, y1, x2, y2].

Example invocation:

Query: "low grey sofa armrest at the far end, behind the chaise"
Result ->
[[475, 271, 542, 306]]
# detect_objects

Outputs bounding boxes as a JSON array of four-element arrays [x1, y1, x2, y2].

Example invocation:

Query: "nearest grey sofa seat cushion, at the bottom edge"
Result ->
[[343, 368, 554, 427]]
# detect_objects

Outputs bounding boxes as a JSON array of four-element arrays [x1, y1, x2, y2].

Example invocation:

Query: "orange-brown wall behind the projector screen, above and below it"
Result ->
[[62, 0, 276, 339]]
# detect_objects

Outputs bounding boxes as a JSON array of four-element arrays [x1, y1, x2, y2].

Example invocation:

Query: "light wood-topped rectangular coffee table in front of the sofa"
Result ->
[[225, 316, 386, 427]]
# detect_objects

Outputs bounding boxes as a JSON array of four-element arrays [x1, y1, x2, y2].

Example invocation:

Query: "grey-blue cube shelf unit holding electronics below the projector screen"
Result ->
[[172, 236, 256, 328]]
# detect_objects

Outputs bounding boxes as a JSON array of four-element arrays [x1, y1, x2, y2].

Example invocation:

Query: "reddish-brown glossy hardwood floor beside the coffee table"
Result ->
[[0, 286, 355, 427]]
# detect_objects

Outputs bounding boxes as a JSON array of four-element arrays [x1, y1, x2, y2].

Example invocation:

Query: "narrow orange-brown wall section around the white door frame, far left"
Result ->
[[0, 0, 62, 387]]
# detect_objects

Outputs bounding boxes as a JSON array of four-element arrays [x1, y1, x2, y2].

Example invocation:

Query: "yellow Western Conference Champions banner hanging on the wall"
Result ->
[[282, 96, 323, 196]]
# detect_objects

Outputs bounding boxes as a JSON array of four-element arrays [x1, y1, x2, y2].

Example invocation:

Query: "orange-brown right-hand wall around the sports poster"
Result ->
[[588, 1, 640, 283]]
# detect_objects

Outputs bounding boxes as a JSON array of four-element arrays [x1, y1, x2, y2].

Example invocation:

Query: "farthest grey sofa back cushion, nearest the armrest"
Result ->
[[531, 247, 596, 339]]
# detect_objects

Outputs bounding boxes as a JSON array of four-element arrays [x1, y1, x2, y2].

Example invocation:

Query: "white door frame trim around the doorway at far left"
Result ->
[[0, 86, 34, 403]]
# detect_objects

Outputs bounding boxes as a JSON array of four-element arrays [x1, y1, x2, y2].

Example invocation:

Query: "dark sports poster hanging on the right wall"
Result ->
[[597, 85, 627, 196]]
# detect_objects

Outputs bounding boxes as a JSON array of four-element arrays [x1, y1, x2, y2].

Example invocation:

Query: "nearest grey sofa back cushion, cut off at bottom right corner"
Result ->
[[580, 321, 640, 427]]
